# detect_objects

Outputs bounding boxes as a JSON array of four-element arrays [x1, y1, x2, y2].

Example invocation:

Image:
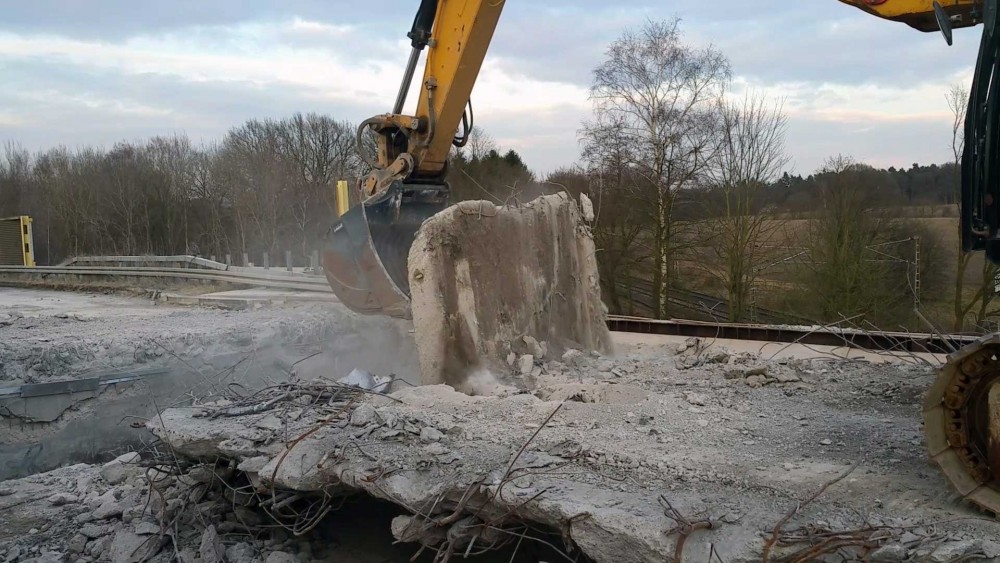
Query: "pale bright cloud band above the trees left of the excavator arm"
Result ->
[[0, 59, 383, 150]]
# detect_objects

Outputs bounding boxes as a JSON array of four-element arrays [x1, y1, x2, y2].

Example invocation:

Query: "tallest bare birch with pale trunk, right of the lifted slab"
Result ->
[[584, 18, 730, 317]]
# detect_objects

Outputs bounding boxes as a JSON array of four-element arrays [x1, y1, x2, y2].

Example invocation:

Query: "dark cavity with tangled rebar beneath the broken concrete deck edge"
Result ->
[[139, 464, 591, 563]]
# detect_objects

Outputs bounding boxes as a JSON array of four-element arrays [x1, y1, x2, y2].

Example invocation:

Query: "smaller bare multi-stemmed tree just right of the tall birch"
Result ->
[[703, 92, 789, 322]]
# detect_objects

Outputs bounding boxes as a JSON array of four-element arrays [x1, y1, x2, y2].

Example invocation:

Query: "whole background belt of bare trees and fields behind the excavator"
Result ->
[[0, 19, 995, 329]]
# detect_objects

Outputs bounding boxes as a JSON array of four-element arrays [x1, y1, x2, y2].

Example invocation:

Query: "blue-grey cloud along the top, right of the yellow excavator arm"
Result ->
[[493, 0, 979, 87]]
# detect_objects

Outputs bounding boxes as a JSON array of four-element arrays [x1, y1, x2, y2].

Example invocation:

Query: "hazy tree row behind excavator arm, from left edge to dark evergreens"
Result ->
[[0, 114, 534, 264]]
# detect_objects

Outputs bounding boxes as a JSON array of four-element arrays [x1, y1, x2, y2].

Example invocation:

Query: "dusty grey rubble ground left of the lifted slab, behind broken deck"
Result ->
[[0, 287, 420, 480]]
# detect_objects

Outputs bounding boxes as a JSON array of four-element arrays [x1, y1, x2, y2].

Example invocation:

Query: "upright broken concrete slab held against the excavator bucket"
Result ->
[[409, 194, 612, 394]]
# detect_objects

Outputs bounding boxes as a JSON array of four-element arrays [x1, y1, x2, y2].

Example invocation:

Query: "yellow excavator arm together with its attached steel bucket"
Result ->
[[323, 0, 504, 318]]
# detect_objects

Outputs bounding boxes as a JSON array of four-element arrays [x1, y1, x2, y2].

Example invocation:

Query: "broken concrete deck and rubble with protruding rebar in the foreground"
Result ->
[[0, 316, 1000, 563]]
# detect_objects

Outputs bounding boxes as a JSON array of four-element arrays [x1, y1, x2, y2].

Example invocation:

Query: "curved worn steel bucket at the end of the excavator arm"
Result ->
[[323, 181, 448, 319]]
